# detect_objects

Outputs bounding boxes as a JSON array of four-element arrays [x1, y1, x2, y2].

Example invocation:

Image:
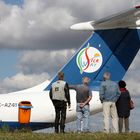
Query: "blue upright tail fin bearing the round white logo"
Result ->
[[45, 29, 140, 90]]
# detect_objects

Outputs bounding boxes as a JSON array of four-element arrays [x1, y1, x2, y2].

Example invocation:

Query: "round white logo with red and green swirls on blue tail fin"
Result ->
[[76, 43, 103, 74]]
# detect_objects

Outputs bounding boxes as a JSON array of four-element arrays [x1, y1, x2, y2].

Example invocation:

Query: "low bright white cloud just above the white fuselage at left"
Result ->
[[0, 72, 50, 93]]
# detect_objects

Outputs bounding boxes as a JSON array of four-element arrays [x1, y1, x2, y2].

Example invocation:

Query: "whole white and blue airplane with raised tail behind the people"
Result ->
[[0, 6, 140, 130]]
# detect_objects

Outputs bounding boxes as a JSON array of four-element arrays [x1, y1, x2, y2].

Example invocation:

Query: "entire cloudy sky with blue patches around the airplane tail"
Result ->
[[0, 0, 140, 94]]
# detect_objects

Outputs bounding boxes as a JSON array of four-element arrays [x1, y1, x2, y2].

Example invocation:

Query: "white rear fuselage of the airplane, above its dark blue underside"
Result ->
[[0, 90, 102, 123]]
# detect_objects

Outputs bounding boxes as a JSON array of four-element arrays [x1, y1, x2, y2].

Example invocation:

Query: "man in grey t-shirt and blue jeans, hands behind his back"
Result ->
[[70, 77, 92, 133]]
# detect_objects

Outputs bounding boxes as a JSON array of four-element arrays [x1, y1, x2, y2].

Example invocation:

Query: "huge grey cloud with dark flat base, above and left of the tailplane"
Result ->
[[0, 0, 136, 50]]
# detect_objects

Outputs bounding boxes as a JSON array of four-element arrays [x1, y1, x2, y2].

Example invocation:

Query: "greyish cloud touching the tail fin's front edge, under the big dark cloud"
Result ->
[[17, 49, 75, 76]]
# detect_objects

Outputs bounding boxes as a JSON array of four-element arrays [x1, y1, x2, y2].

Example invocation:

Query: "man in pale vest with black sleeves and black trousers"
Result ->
[[50, 72, 71, 133]]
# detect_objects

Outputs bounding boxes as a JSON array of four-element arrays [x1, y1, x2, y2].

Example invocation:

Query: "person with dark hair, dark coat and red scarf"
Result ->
[[116, 81, 131, 133]]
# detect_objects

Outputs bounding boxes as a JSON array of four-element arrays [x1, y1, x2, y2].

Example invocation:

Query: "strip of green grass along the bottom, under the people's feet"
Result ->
[[0, 131, 140, 140]]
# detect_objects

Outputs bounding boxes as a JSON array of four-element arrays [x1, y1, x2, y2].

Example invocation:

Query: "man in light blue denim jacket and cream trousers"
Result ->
[[100, 72, 120, 133]]
